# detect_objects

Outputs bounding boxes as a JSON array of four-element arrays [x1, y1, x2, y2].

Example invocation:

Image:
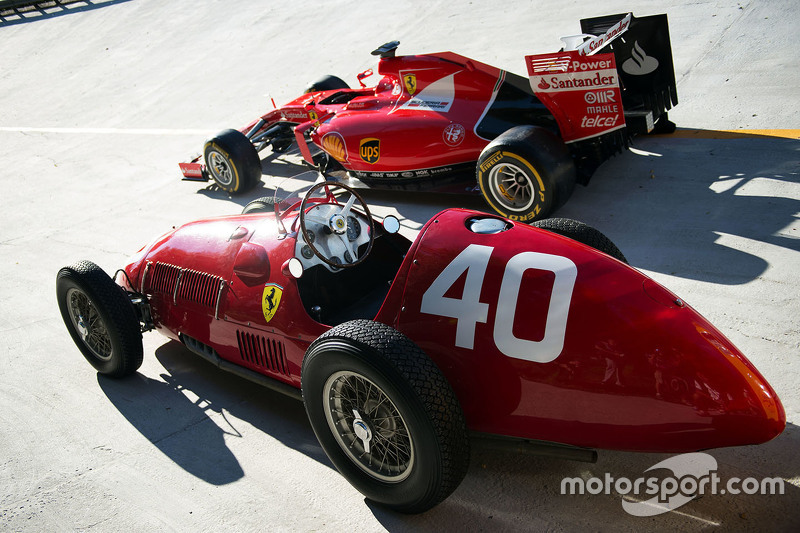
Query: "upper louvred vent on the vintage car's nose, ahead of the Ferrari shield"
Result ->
[[143, 262, 222, 308]]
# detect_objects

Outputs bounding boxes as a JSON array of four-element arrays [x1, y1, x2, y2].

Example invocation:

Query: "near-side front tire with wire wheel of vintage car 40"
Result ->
[[56, 261, 143, 378]]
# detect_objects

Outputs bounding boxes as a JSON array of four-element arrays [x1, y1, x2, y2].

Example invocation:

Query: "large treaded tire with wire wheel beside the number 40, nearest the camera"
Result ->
[[301, 320, 469, 513]]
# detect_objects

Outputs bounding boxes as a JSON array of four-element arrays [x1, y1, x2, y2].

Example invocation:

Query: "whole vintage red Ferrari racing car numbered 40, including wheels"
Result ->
[[56, 182, 786, 512]]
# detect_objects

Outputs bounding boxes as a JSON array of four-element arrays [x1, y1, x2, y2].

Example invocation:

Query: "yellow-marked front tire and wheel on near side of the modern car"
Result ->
[[203, 129, 261, 194]]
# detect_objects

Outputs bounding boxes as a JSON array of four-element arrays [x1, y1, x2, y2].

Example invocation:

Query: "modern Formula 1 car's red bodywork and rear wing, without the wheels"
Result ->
[[180, 15, 677, 192]]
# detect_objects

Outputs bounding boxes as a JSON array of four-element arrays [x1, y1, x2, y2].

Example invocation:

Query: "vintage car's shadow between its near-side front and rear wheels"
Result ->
[[98, 341, 332, 485]]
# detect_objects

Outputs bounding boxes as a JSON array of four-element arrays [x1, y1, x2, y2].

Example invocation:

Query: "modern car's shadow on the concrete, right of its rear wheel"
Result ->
[[556, 130, 800, 285]]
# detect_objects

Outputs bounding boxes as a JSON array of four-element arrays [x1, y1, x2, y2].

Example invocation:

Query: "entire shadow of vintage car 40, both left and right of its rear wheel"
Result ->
[[98, 341, 800, 531]]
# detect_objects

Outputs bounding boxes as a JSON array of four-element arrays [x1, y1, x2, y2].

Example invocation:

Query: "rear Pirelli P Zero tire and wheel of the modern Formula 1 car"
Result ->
[[476, 126, 577, 222]]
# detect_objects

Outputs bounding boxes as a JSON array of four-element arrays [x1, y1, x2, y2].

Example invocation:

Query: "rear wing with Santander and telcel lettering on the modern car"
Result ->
[[525, 13, 678, 183]]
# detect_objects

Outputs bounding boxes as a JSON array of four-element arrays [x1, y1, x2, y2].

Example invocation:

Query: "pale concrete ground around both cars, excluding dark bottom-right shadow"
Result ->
[[0, 0, 800, 532]]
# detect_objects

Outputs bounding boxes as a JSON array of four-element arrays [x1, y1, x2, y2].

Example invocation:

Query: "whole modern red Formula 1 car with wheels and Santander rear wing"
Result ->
[[180, 14, 677, 221]]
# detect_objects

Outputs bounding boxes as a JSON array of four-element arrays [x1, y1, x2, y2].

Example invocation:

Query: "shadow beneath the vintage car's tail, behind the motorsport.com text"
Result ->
[[369, 424, 800, 532]]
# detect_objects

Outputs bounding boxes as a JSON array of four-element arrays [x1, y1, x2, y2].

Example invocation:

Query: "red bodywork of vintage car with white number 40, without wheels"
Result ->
[[119, 209, 785, 452]]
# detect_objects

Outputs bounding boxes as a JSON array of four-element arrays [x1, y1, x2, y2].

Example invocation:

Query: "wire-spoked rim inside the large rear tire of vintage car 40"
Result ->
[[324, 371, 414, 483]]
